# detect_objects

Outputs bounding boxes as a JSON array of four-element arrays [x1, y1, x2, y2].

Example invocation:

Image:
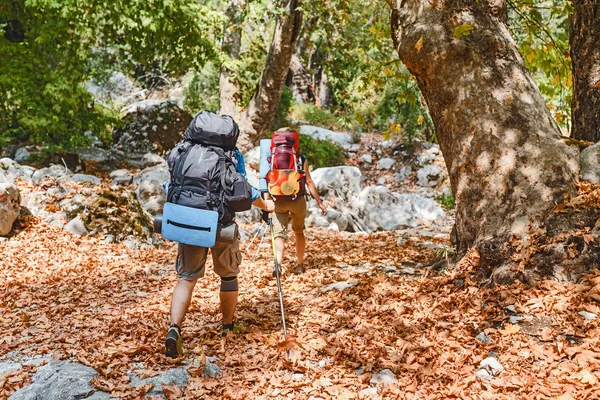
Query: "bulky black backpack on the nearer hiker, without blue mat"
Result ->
[[167, 111, 252, 225]]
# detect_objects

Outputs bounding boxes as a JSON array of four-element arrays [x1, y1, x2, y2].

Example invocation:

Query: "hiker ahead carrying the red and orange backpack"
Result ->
[[267, 128, 327, 275]]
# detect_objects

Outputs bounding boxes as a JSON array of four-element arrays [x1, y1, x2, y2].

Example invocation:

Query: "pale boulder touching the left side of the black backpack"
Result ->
[[133, 166, 171, 215]]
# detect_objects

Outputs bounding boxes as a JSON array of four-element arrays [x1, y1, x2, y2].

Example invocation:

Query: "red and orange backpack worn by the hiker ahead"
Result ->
[[266, 131, 306, 200]]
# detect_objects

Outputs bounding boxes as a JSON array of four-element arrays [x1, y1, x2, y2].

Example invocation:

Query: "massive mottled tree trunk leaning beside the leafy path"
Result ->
[[387, 0, 579, 276]]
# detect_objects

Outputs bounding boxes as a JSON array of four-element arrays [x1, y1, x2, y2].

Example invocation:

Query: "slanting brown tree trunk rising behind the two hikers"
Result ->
[[238, 0, 302, 151]]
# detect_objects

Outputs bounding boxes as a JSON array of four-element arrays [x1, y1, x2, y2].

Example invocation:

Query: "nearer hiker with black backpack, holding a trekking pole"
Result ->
[[163, 111, 274, 358]]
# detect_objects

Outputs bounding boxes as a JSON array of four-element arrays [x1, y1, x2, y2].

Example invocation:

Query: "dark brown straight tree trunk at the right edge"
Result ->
[[569, 0, 600, 142]]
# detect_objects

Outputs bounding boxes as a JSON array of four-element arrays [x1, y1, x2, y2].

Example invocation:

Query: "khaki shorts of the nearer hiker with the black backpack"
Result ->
[[175, 233, 242, 281]]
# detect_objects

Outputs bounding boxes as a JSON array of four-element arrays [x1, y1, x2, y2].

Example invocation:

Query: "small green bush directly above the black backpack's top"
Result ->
[[183, 62, 220, 115]]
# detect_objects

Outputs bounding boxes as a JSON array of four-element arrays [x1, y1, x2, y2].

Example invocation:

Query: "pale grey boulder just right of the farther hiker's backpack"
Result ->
[[311, 166, 362, 201]]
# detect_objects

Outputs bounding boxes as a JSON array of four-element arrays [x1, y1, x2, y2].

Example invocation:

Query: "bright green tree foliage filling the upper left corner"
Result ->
[[0, 0, 218, 148]]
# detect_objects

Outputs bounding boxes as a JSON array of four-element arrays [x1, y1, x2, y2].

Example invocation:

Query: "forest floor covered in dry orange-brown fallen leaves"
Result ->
[[0, 211, 600, 399]]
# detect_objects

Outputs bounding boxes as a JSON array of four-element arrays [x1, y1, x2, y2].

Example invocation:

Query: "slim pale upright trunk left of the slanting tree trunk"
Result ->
[[219, 0, 246, 121]]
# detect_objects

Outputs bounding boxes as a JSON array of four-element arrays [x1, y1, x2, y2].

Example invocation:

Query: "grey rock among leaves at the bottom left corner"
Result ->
[[10, 360, 110, 400]]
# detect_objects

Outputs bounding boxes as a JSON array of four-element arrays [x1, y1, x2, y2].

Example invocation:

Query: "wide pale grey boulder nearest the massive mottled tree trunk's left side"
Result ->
[[353, 186, 445, 231]]
